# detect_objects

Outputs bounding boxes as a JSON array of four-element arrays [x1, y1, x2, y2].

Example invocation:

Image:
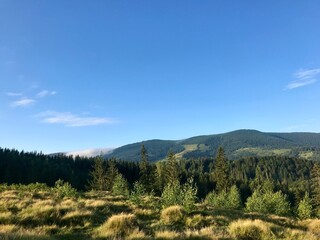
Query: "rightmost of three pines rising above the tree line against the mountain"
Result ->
[[213, 147, 229, 192]]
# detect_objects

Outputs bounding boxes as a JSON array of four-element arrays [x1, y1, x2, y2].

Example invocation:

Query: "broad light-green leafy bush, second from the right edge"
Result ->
[[246, 190, 290, 216]]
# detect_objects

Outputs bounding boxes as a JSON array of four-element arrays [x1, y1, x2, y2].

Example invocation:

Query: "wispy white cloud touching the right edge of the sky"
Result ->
[[285, 68, 320, 90]]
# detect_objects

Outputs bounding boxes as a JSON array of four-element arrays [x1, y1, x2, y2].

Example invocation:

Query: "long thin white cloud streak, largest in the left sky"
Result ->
[[39, 111, 114, 127]]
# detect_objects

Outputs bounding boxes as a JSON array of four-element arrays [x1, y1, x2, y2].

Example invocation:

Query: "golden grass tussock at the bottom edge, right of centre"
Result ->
[[229, 219, 271, 240]]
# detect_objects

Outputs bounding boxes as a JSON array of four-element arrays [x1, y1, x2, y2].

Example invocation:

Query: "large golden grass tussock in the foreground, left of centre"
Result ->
[[98, 213, 138, 239]]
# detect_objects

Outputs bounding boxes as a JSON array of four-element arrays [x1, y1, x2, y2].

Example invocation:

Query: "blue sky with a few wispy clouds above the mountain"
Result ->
[[0, 0, 320, 153]]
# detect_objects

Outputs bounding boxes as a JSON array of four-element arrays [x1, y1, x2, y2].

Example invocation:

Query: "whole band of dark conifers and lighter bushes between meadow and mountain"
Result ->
[[0, 146, 320, 218]]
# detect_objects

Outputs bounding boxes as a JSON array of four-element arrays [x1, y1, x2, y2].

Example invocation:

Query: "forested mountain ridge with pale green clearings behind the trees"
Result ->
[[105, 129, 320, 161]]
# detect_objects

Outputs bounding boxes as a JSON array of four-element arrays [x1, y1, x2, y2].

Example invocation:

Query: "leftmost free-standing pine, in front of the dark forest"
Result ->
[[88, 156, 107, 191]]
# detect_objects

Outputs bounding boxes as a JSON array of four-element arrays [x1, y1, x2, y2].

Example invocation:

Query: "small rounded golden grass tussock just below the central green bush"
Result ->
[[160, 205, 186, 225]]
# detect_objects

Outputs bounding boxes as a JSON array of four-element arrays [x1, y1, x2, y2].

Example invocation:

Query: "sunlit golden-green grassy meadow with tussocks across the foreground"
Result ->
[[0, 188, 320, 240]]
